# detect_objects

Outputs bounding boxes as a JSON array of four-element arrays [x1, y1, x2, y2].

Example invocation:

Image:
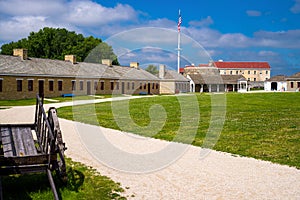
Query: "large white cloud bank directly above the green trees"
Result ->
[[0, 0, 138, 43]]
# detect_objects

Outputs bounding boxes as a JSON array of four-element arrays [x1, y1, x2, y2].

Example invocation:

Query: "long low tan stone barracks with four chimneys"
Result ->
[[0, 49, 189, 100]]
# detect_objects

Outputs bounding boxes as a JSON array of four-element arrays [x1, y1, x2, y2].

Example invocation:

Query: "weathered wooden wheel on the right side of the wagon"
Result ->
[[48, 107, 67, 182]]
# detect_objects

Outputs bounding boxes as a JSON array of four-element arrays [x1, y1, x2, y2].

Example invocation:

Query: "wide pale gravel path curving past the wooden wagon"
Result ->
[[0, 99, 300, 199]]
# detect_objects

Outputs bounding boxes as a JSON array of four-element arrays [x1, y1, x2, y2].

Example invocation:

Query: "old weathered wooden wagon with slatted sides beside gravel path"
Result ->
[[0, 95, 67, 199]]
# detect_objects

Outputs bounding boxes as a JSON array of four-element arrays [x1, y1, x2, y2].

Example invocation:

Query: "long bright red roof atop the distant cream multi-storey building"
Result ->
[[214, 62, 271, 69]]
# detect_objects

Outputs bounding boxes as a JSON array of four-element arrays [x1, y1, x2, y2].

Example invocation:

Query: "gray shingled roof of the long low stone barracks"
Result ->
[[0, 55, 159, 80]]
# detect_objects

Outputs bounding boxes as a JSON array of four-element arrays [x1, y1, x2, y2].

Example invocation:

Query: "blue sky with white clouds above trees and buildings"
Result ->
[[0, 0, 300, 75]]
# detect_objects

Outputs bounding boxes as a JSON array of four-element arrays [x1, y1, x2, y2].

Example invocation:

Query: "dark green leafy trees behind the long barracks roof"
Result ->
[[1, 27, 119, 65]]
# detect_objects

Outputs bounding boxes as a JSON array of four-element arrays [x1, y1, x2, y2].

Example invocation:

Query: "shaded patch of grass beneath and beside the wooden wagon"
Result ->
[[2, 159, 126, 200]]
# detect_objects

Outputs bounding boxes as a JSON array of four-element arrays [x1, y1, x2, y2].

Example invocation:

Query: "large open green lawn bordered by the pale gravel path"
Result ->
[[58, 93, 300, 169]]
